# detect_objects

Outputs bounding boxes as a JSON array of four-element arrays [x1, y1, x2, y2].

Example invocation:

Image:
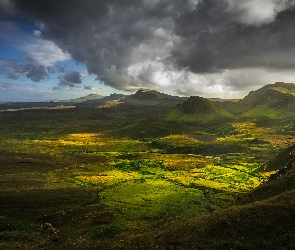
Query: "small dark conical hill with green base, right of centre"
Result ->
[[165, 96, 232, 122]]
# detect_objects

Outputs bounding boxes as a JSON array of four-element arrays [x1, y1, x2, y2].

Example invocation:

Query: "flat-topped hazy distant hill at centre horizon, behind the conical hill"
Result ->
[[122, 88, 187, 107]]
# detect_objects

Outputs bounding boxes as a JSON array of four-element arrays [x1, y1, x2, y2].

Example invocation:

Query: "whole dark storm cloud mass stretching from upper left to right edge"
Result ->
[[11, 0, 295, 92]]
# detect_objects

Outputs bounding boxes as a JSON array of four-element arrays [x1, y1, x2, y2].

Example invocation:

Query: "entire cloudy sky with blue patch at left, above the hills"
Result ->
[[0, 0, 295, 102]]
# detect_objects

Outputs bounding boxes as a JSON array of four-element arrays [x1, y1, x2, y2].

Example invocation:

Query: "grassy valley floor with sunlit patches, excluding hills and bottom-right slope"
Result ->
[[0, 101, 295, 249]]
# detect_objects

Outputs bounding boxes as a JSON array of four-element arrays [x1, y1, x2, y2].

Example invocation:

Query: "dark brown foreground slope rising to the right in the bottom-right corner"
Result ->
[[145, 146, 295, 249]]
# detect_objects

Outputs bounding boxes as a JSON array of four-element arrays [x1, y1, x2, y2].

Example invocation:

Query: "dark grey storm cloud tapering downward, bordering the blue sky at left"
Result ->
[[9, 0, 189, 88]]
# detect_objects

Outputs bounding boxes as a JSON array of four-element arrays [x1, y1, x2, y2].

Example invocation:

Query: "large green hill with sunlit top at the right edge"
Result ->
[[228, 82, 295, 117]]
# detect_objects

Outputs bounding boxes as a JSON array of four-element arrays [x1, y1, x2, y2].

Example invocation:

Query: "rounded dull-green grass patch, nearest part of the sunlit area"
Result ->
[[101, 179, 211, 220]]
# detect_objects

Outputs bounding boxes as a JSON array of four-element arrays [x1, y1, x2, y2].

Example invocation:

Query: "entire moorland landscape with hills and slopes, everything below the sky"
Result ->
[[0, 82, 295, 250]]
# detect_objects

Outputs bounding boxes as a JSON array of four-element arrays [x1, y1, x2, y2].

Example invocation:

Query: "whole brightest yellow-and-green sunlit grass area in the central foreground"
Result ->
[[74, 160, 263, 220]]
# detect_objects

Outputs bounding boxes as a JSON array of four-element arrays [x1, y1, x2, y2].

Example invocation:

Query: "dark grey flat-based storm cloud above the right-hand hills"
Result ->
[[171, 1, 295, 73]]
